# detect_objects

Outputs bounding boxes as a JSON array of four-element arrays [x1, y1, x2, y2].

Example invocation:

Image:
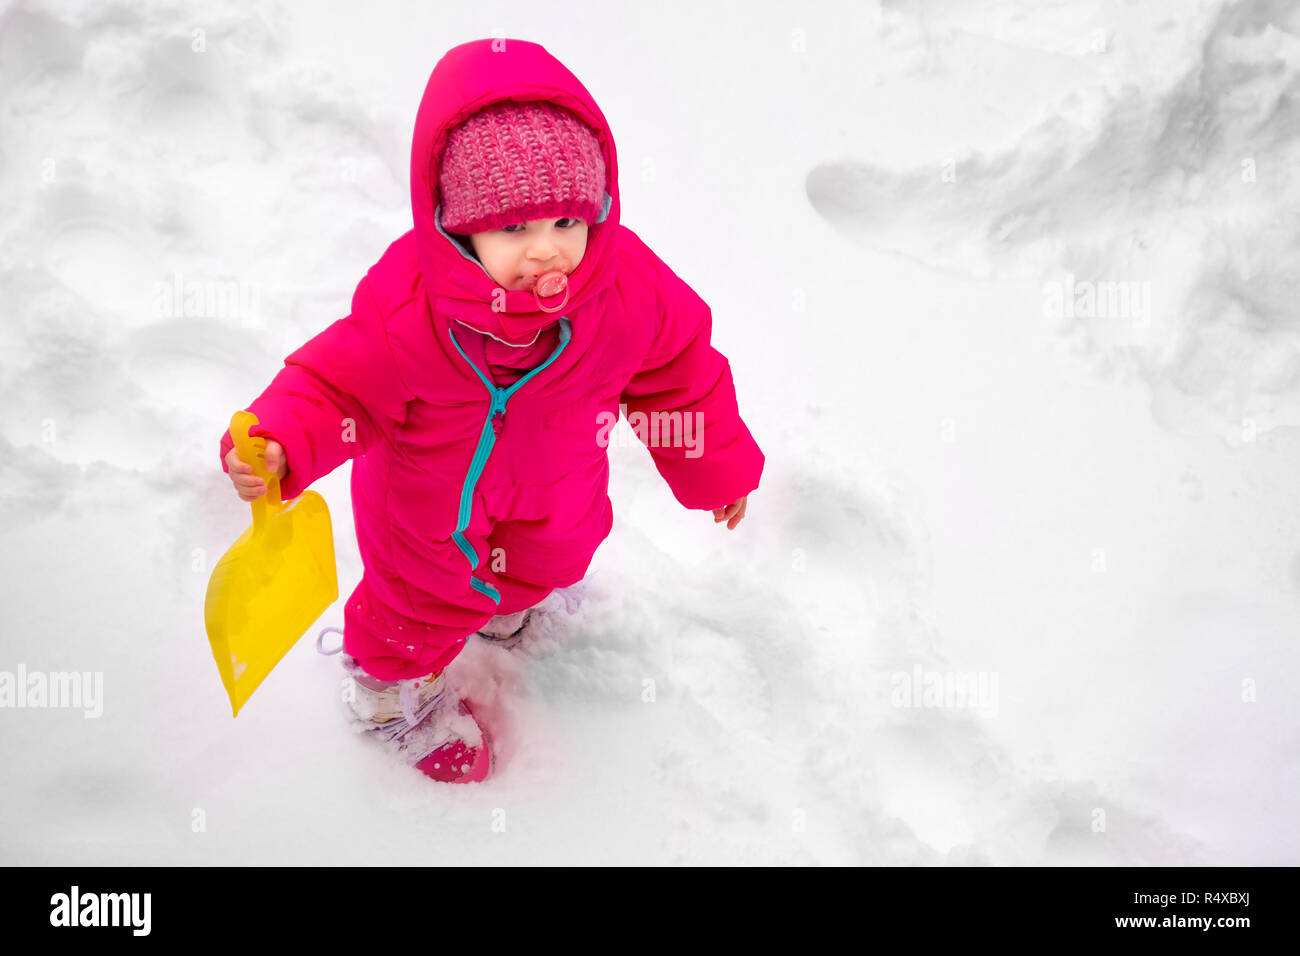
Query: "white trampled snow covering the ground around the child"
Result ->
[[0, 0, 1300, 865]]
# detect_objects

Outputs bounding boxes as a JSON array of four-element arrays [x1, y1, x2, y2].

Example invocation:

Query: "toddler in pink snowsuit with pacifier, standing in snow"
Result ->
[[221, 39, 764, 783]]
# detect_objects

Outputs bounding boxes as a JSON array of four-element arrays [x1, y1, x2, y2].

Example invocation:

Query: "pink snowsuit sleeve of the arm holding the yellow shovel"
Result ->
[[221, 278, 415, 501]]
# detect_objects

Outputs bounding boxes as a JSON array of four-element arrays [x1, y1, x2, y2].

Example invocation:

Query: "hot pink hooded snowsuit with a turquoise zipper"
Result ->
[[213, 39, 763, 679]]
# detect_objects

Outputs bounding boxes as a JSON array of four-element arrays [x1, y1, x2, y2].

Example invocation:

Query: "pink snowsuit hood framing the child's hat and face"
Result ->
[[411, 39, 619, 345]]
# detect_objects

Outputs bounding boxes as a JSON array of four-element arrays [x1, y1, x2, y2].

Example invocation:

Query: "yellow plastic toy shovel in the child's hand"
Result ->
[[203, 411, 338, 717]]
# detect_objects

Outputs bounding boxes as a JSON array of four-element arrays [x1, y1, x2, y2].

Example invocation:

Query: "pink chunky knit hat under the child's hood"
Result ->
[[438, 100, 605, 235]]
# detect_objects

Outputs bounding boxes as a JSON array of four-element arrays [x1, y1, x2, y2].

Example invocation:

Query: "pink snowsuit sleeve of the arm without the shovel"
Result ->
[[620, 258, 764, 510]]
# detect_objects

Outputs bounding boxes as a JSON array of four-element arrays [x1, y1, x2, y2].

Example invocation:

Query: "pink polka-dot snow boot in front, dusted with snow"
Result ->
[[316, 627, 493, 783]]
